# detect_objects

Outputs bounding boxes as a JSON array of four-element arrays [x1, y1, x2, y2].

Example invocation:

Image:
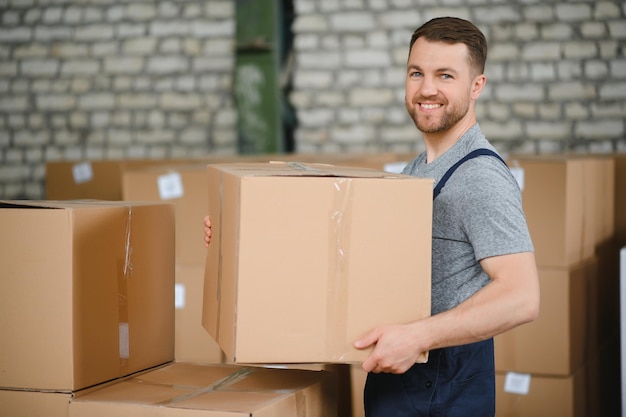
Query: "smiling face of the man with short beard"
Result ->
[[405, 38, 482, 133]]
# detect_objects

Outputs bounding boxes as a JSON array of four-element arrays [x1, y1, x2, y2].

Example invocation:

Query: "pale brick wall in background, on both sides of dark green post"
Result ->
[[0, 0, 626, 198]]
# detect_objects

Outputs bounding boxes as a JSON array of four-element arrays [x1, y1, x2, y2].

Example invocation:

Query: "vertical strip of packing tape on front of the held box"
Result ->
[[326, 178, 354, 361]]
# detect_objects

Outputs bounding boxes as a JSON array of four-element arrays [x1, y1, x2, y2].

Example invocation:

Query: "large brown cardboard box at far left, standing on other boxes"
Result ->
[[0, 201, 174, 392]]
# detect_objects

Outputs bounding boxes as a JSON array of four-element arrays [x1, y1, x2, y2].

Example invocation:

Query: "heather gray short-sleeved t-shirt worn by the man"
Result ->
[[403, 124, 534, 314]]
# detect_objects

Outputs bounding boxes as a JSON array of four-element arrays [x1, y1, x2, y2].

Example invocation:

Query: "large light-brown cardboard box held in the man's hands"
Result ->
[[202, 163, 433, 363]]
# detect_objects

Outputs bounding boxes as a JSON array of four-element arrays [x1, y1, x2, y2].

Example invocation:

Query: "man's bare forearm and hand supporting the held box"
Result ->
[[355, 252, 539, 373]]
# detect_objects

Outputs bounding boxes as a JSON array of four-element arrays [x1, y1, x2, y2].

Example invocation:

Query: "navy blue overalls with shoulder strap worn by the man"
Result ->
[[364, 149, 506, 417]]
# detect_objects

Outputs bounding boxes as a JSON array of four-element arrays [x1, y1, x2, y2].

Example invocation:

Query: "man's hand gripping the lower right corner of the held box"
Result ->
[[354, 322, 422, 374]]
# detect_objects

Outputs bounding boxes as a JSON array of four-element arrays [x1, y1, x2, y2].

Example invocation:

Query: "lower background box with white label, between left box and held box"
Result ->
[[174, 264, 226, 363]]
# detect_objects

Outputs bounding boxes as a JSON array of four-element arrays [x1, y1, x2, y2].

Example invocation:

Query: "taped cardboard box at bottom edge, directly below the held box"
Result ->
[[69, 363, 337, 417]]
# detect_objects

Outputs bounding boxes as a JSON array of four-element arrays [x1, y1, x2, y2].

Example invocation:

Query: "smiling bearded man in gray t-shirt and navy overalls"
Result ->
[[205, 17, 539, 417]]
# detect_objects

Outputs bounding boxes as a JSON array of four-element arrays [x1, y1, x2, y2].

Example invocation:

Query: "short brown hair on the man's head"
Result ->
[[409, 17, 487, 74]]
